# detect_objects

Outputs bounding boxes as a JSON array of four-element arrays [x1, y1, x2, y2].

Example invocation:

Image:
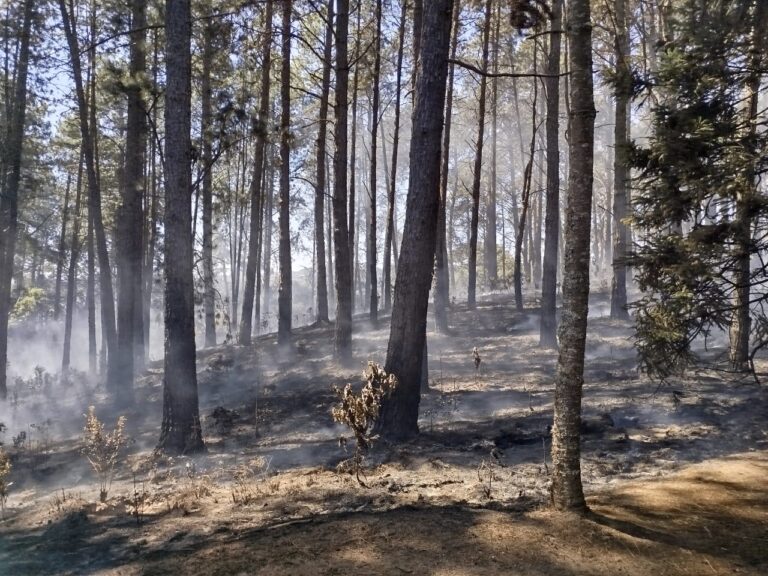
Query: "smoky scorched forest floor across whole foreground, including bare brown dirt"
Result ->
[[0, 295, 768, 576]]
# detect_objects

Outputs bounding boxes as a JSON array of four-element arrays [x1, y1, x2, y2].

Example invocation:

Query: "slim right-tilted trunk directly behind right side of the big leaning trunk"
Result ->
[[435, 0, 461, 334]]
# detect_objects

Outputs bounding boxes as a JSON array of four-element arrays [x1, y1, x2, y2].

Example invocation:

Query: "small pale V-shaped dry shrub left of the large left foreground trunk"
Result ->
[[82, 406, 128, 502]]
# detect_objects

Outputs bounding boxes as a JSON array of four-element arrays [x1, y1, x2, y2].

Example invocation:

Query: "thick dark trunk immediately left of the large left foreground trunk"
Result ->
[[114, 0, 147, 405]]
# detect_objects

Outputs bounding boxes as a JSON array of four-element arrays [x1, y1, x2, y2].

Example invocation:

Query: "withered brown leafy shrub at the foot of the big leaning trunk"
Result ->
[[331, 362, 397, 486]]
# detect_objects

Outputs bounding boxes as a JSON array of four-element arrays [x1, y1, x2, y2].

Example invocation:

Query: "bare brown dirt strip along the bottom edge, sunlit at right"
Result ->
[[115, 452, 768, 576]]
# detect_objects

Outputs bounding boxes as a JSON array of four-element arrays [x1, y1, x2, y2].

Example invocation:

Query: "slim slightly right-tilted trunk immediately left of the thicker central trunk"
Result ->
[[315, 0, 335, 323]]
